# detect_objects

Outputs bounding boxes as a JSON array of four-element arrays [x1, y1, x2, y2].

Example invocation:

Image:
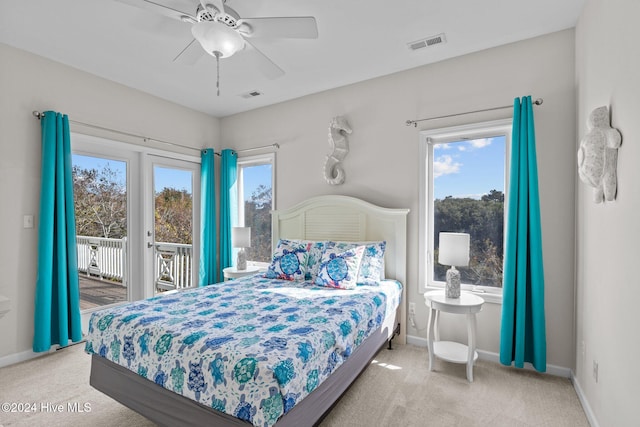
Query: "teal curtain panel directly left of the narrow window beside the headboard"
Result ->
[[220, 150, 238, 280]]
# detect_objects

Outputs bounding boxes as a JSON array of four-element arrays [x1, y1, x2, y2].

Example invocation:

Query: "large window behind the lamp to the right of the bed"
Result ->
[[420, 120, 511, 293]]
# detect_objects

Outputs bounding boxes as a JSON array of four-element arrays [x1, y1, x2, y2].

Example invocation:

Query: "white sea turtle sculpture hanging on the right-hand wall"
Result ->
[[578, 107, 622, 203]]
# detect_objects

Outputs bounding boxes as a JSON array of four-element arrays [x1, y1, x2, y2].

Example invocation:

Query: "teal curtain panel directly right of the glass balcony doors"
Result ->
[[198, 148, 217, 286]]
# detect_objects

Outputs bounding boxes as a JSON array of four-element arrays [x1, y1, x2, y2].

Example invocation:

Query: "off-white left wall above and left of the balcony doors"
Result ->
[[0, 44, 220, 365]]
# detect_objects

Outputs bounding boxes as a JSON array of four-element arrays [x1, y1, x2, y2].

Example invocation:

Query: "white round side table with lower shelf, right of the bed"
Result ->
[[424, 290, 484, 382]]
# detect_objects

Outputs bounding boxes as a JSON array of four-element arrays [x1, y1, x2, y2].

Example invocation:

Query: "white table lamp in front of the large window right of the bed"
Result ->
[[438, 233, 470, 298]]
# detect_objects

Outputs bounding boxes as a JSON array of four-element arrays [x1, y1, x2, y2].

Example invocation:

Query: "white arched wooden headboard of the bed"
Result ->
[[271, 196, 409, 344]]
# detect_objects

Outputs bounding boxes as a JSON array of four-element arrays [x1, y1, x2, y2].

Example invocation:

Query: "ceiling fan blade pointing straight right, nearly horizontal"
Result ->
[[238, 16, 318, 39]]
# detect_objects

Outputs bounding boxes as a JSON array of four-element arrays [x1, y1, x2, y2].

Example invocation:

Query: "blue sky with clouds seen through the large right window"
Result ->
[[433, 136, 505, 199]]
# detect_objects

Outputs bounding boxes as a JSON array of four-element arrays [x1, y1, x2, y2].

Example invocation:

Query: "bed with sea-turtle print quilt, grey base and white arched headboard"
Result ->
[[86, 196, 408, 427]]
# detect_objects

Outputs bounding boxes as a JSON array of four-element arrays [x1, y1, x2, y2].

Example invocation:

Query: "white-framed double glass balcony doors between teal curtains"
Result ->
[[71, 133, 200, 327]]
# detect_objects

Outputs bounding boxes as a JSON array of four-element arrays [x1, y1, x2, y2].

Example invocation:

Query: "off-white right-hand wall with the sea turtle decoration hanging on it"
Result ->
[[575, 0, 640, 426]]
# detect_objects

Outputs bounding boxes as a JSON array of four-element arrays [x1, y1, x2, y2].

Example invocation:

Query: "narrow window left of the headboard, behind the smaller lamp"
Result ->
[[238, 153, 275, 263]]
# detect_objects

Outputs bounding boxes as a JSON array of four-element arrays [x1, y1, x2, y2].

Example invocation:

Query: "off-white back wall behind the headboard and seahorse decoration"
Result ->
[[221, 30, 576, 368]]
